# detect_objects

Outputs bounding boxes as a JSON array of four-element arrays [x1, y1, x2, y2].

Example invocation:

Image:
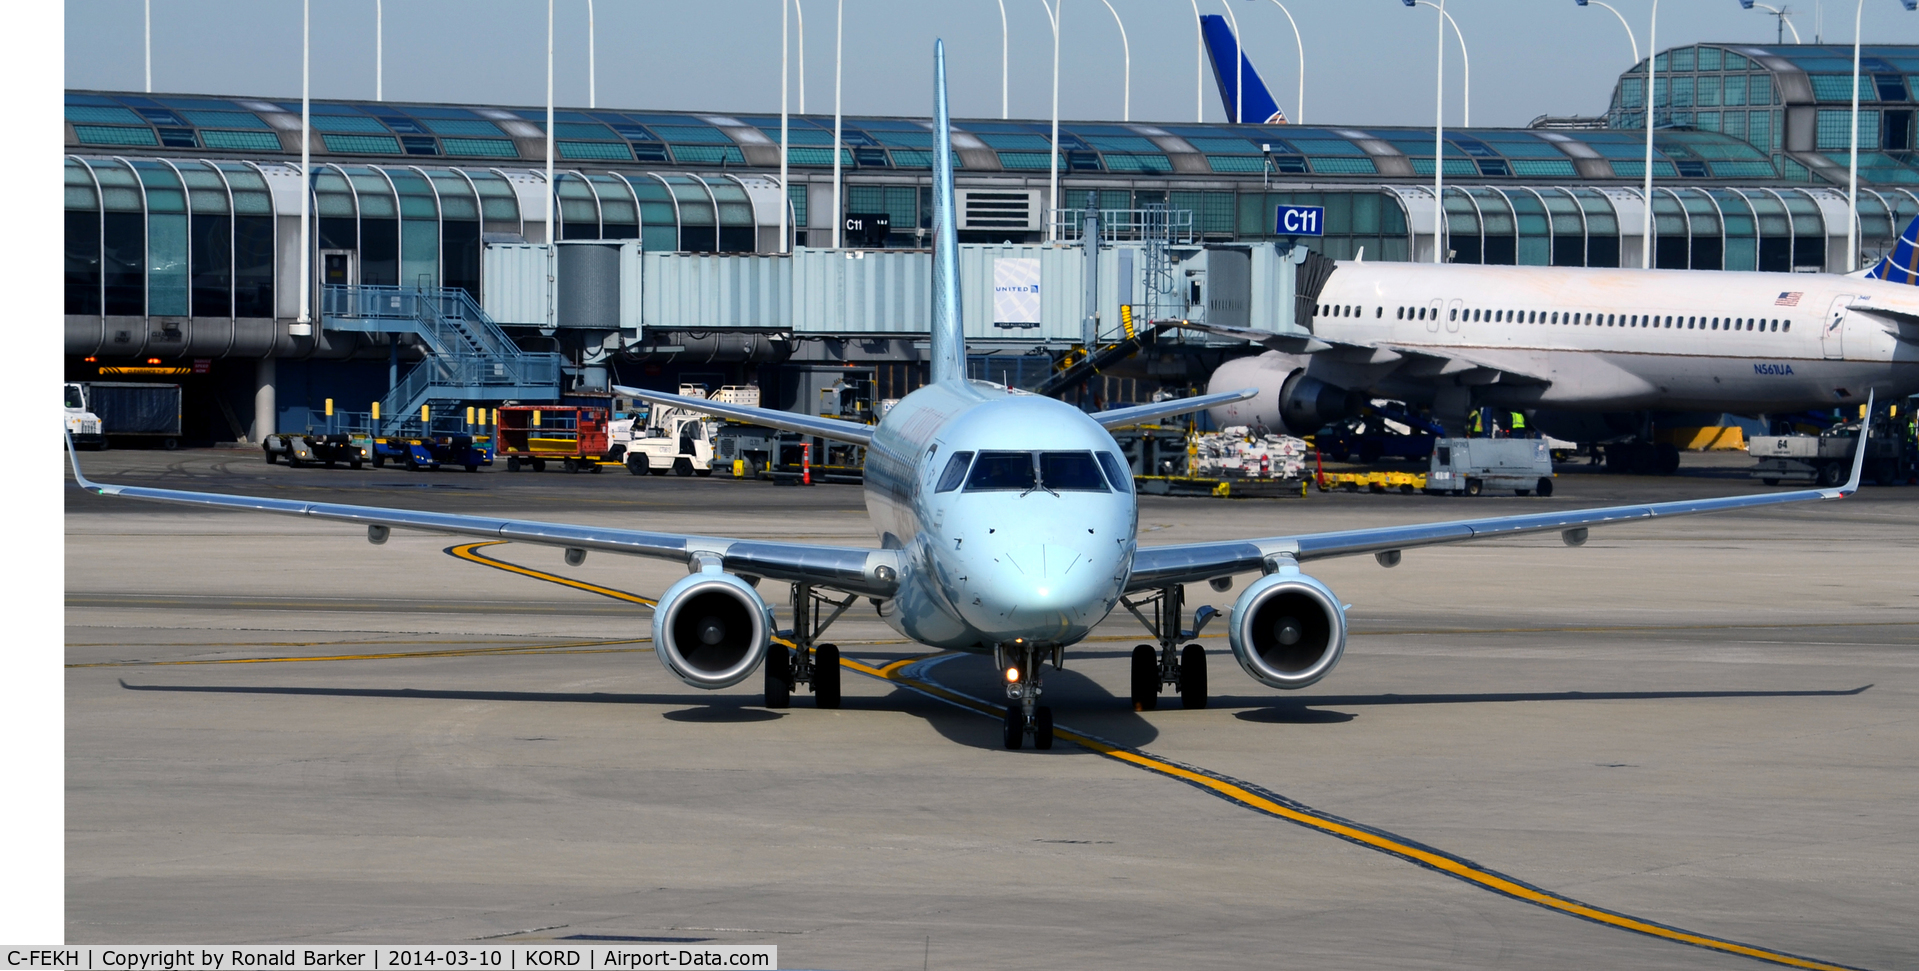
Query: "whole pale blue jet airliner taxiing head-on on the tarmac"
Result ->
[[69, 44, 1863, 748]]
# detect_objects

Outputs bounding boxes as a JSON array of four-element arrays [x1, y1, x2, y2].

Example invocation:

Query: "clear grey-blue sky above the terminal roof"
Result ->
[[65, 0, 1919, 127]]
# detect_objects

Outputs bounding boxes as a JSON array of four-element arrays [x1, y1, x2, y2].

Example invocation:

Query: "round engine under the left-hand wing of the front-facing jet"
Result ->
[[652, 572, 773, 691]]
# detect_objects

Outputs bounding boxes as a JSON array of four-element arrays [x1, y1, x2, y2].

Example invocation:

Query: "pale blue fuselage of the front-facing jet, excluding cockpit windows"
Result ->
[[865, 382, 1138, 651]]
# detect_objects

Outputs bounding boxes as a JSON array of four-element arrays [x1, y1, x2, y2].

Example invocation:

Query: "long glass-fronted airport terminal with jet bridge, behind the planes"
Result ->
[[65, 44, 1919, 439]]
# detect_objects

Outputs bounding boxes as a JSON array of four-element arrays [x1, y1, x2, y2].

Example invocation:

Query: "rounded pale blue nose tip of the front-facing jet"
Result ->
[[960, 543, 1119, 641]]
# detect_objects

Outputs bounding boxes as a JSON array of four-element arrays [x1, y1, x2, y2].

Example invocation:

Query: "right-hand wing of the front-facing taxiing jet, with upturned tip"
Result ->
[[1126, 397, 1871, 593]]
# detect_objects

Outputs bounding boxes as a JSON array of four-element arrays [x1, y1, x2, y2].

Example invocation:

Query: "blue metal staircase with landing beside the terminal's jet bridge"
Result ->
[[320, 284, 560, 432]]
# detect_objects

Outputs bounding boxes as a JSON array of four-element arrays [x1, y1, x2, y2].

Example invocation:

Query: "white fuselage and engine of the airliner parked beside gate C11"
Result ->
[[1211, 261, 1919, 432]]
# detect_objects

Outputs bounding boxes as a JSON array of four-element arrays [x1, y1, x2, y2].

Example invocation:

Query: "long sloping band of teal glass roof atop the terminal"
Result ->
[[65, 89, 1826, 182]]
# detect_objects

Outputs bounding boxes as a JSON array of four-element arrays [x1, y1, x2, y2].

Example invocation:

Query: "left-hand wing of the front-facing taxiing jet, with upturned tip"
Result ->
[[67, 438, 900, 597]]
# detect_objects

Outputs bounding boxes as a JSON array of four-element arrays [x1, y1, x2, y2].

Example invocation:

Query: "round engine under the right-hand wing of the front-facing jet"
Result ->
[[1226, 570, 1345, 689]]
